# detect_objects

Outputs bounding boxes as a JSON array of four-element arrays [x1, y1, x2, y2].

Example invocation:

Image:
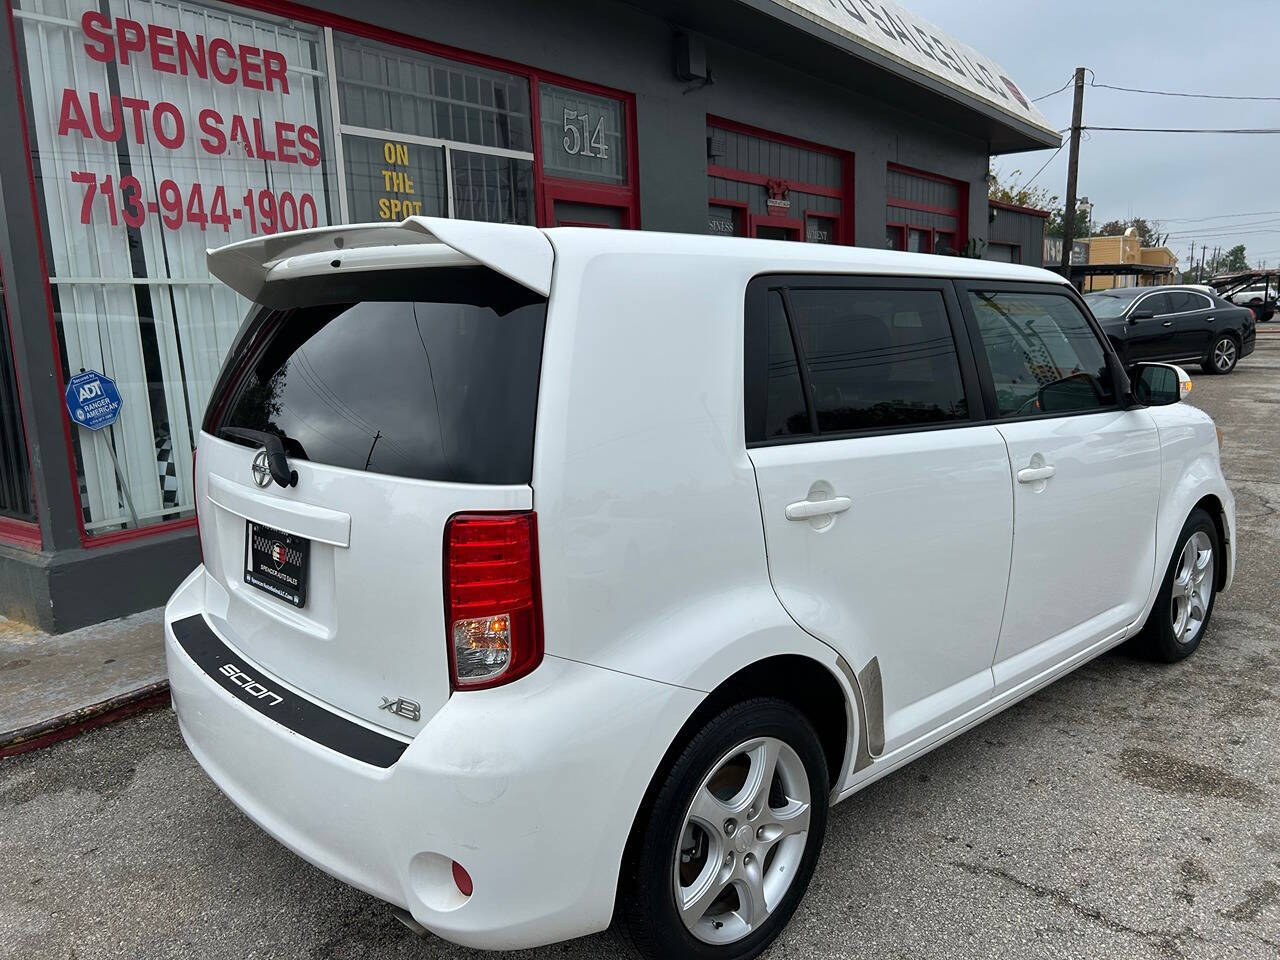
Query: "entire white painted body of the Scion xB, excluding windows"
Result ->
[[165, 219, 1235, 948]]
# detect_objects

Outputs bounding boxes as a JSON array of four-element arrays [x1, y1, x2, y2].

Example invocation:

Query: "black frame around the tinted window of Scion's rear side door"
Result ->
[[742, 271, 987, 449]]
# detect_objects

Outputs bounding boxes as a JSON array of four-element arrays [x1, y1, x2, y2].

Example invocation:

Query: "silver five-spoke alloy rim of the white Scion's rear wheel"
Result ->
[[673, 737, 813, 945]]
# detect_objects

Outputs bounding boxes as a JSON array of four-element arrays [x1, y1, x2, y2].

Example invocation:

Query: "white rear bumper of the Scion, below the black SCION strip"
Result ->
[[165, 568, 701, 948]]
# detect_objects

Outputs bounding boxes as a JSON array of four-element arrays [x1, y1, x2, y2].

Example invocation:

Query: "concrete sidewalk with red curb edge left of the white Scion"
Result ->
[[0, 608, 169, 756]]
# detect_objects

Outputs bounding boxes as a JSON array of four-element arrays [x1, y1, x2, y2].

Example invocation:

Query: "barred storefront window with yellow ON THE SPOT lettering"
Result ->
[[334, 33, 535, 224]]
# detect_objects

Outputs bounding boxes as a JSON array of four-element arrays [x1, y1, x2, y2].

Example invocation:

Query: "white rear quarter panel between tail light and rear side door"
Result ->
[[532, 239, 836, 691]]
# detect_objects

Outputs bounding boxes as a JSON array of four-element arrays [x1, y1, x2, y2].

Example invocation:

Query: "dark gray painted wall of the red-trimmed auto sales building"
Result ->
[[0, 0, 988, 630]]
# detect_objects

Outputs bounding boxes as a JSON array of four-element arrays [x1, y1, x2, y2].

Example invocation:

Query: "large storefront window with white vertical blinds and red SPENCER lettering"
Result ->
[[14, 0, 335, 535]]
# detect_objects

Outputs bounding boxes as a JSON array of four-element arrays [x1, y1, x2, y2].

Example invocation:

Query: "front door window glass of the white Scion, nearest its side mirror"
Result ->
[[969, 291, 1115, 417]]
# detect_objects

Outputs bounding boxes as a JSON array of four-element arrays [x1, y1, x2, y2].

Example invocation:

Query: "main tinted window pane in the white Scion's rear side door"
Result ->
[[788, 287, 969, 434]]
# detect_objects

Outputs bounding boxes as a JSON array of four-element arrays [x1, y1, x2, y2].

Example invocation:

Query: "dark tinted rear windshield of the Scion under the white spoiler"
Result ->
[[205, 266, 547, 484]]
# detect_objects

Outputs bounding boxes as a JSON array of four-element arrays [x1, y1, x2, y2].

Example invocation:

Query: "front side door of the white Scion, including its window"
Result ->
[[961, 284, 1161, 692]]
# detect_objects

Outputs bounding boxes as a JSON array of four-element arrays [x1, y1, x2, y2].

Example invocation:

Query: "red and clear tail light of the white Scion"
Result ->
[[444, 512, 543, 690]]
